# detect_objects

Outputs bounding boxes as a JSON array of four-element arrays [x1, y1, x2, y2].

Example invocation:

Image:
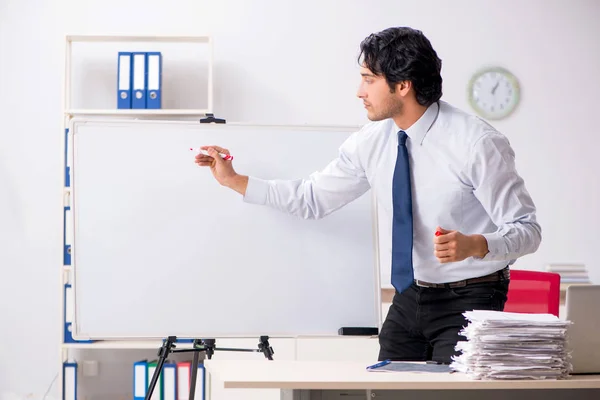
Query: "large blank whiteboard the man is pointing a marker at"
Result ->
[[69, 119, 381, 340]]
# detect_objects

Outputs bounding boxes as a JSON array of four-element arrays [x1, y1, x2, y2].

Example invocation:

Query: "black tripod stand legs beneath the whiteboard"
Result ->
[[145, 336, 275, 400]]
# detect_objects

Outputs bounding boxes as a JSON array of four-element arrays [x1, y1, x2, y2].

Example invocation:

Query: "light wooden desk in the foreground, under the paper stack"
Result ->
[[205, 360, 600, 400]]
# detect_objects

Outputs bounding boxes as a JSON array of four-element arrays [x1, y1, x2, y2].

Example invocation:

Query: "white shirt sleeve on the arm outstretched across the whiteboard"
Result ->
[[244, 131, 370, 219]]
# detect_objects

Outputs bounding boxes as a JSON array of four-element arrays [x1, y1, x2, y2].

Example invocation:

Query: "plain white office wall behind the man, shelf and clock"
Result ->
[[0, 0, 600, 398]]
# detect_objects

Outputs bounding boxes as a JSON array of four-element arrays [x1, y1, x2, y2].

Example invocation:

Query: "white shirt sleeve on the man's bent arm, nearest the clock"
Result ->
[[468, 132, 542, 260]]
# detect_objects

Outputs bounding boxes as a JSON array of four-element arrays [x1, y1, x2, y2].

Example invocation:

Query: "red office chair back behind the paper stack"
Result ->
[[504, 269, 560, 317]]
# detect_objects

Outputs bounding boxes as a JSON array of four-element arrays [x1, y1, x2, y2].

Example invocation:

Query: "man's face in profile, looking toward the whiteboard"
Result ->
[[356, 67, 402, 121]]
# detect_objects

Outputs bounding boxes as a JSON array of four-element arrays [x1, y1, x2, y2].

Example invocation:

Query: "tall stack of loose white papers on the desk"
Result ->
[[450, 310, 571, 379]]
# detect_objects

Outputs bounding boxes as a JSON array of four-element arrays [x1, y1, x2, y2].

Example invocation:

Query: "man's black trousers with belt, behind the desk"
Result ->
[[379, 279, 509, 363]]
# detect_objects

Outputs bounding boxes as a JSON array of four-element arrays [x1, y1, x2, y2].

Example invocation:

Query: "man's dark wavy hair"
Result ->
[[358, 27, 442, 106]]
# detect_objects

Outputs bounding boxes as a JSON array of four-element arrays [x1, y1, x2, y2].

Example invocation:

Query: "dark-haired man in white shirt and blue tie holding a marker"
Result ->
[[195, 27, 541, 363]]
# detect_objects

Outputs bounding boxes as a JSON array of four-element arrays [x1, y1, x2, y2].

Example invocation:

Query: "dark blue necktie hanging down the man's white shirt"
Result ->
[[392, 131, 414, 293]]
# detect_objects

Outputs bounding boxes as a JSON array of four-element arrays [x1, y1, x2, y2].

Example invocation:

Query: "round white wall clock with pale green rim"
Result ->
[[468, 68, 520, 119]]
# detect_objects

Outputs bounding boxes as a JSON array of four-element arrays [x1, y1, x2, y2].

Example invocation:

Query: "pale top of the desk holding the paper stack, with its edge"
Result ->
[[204, 360, 600, 390]]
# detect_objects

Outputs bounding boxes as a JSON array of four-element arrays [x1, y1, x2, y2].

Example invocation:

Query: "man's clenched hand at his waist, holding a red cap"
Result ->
[[433, 226, 488, 264]]
